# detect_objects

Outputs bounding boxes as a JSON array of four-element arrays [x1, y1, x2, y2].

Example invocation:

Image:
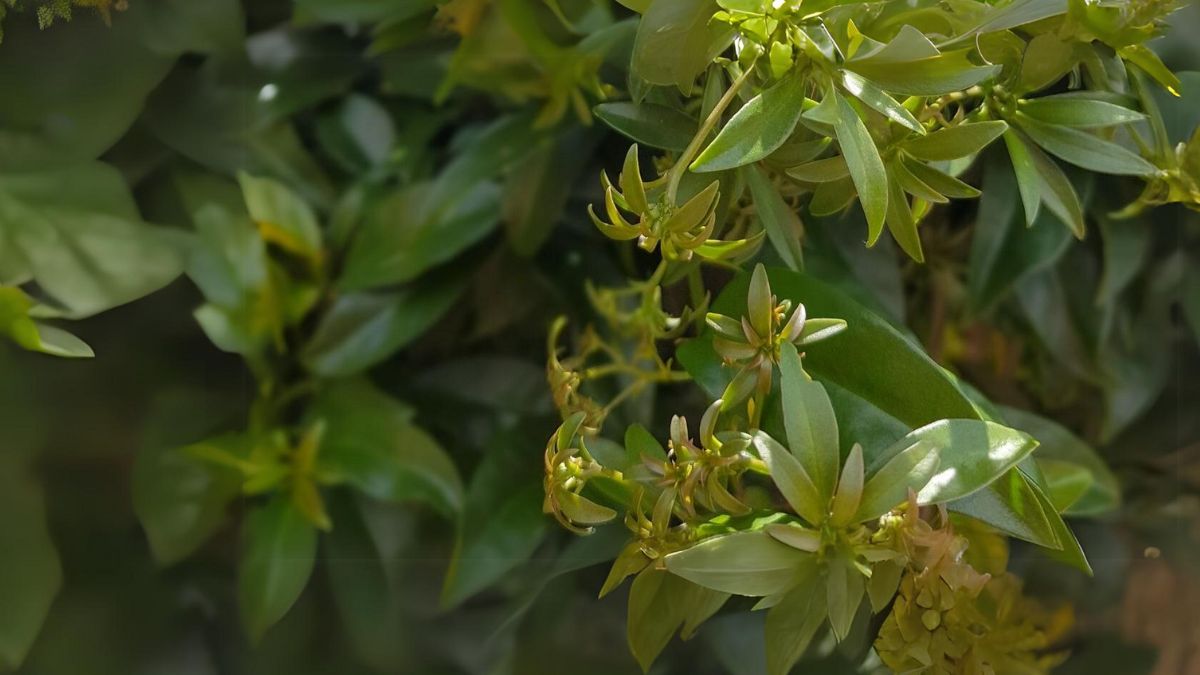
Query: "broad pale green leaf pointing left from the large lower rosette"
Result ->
[[666, 531, 812, 597]]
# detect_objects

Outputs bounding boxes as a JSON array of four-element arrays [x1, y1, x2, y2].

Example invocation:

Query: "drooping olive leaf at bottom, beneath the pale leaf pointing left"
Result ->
[[625, 568, 728, 671]]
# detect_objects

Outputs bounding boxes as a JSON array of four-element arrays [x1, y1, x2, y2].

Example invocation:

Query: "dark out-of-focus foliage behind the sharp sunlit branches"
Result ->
[[0, 0, 1200, 675]]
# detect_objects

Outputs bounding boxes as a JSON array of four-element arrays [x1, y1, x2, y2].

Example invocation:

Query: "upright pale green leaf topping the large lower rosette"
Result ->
[[779, 342, 841, 499]]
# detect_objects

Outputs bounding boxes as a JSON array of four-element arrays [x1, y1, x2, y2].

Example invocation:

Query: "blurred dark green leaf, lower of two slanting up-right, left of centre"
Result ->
[[302, 277, 464, 377]]
